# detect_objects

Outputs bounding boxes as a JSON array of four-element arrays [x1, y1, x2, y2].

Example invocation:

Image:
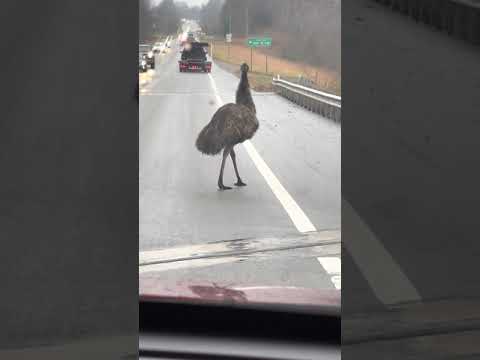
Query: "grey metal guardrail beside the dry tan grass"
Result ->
[[272, 75, 342, 122]]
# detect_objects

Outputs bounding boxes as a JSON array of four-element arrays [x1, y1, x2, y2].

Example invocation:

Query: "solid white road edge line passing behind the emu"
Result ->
[[208, 73, 317, 233]]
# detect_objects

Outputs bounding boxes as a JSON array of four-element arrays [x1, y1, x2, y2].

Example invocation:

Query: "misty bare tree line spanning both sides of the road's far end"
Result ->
[[139, 0, 341, 72]]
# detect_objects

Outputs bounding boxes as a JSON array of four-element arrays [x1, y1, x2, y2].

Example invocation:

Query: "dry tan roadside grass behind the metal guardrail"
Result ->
[[209, 39, 341, 95]]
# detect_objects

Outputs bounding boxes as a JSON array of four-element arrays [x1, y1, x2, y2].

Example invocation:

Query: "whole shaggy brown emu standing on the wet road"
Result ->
[[195, 64, 259, 190]]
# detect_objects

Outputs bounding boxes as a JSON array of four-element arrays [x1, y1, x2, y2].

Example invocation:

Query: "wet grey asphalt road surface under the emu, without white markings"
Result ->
[[139, 44, 341, 288]]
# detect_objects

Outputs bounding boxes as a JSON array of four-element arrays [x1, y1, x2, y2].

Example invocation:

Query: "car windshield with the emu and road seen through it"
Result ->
[[139, 0, 341, 306]]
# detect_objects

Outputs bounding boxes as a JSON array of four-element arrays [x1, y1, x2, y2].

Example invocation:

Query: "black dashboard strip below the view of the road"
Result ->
[[139, 302, 341, 360]]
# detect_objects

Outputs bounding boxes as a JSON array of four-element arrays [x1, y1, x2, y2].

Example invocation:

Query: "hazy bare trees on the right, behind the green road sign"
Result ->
[[200, 0, 341, 72]]
